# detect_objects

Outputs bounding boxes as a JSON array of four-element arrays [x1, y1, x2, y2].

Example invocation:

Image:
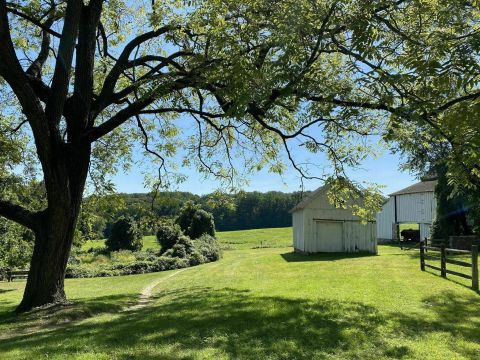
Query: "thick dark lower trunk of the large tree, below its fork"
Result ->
[[16, 145, 90, 312]]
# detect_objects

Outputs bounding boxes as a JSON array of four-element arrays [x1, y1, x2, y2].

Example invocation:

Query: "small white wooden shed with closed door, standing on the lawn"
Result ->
[[291, 186, 377, 254]]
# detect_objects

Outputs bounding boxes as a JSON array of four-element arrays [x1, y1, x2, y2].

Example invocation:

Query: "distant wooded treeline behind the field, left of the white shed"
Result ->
[[78, 191, 305, 239]]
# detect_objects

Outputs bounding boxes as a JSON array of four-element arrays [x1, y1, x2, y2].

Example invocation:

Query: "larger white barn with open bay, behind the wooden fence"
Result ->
[[377, 180, 437, 242]]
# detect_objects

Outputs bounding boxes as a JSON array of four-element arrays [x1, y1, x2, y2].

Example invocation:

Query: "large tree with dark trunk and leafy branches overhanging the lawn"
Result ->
[[0, 0, 480, 311]]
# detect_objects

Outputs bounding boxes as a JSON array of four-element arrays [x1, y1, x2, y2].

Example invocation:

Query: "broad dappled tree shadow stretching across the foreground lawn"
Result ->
[[0, 288, 409, 359]]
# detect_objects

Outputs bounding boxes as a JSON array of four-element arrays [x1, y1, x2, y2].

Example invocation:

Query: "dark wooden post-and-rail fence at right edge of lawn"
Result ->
[[420, 241, 478, 292]]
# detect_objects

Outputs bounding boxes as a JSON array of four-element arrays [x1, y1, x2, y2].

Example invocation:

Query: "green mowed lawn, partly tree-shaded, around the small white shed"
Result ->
[[0, 229, 480, 360]]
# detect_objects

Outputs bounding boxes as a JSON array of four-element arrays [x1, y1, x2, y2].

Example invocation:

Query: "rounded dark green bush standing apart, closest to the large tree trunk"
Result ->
[[105, 217, 142, 251]]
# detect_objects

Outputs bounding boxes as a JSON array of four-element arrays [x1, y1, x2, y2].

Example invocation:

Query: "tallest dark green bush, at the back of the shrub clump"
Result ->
[[175, 201, 215, 239]]
